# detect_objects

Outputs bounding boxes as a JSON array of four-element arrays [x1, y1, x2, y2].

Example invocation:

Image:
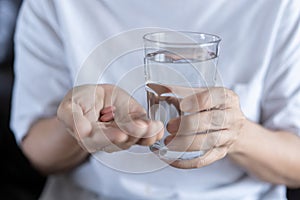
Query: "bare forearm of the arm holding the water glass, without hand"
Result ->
[[229, 121, 300, 187]]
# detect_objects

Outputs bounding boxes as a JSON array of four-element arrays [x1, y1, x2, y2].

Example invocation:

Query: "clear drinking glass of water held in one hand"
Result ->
[[143, 31, 221, 160]]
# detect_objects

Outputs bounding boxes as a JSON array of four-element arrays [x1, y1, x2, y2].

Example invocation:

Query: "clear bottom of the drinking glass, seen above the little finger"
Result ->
[[150, 142, 205, 161]]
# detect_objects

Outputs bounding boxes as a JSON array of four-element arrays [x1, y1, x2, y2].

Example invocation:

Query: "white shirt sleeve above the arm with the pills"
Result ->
[[11, 0, 71, 142]]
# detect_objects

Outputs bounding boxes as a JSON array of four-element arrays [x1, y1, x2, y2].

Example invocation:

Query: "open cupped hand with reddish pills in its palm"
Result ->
[[57, 85, 163, 153]]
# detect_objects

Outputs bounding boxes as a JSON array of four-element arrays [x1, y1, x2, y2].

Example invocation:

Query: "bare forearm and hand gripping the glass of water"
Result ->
[[165, 88, 300, 187]]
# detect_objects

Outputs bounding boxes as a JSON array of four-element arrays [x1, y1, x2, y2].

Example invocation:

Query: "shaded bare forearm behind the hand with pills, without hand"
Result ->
[[22, 117, 88, 174]]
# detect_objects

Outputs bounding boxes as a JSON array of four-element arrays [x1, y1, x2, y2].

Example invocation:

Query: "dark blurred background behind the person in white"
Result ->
[[0, 0, 300, 200]]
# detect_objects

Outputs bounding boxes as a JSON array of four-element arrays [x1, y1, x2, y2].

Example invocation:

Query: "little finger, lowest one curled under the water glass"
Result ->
[[170, 147, 228, 169]]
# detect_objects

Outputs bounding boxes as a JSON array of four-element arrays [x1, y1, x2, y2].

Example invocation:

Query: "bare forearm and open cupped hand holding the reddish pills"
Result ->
[[22, 85, 163, 174]]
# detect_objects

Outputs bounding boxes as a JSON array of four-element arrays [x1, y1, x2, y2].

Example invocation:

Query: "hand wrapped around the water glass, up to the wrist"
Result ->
[[165, 87, 246, 168]]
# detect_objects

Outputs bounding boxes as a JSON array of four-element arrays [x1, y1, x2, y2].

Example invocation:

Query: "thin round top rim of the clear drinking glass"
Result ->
[[143, 31, 222, 46]]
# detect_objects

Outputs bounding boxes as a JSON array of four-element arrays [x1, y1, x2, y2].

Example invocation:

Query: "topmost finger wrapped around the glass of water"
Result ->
[[180, 87, 238, 112]]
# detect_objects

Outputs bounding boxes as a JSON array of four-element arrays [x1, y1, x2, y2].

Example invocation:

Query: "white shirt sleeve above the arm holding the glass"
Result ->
[[261, 0, 300, 136]]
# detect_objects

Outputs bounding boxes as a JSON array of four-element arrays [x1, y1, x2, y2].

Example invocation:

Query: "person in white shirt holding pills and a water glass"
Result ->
[[12, 0, 300, 199]]
